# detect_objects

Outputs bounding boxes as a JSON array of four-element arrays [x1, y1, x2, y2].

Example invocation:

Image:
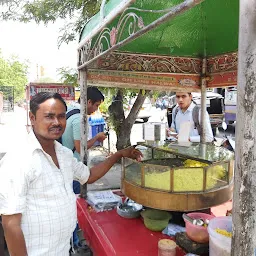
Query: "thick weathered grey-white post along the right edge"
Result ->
[[231, 0, 256, 256]]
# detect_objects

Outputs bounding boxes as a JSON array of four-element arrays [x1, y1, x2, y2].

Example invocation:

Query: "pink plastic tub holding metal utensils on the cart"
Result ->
[[184, 212, 214, 243]]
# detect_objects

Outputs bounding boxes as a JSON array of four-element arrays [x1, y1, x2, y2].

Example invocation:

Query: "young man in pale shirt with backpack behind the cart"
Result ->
[[170, 92, 213, 142]]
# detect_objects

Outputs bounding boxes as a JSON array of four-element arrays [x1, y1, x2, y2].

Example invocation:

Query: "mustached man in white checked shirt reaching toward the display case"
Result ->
[[0, 92, 141, 256]]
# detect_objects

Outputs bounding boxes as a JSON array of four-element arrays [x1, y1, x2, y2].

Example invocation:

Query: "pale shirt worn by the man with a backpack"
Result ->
[[171, 102, 213, 142]]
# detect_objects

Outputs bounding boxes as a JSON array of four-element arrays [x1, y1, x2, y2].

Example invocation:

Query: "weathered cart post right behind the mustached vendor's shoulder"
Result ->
[[79, 69, 88, 198]]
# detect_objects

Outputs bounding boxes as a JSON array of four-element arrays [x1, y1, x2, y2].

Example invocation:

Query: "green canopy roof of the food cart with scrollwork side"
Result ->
[[80, 0, 239, 66]]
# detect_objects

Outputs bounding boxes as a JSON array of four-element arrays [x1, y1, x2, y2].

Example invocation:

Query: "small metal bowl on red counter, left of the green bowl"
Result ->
[[116, 201, 143, 219]]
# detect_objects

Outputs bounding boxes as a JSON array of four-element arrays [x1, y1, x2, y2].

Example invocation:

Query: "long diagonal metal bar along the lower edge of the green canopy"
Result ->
[[78, 0, 204, 70]]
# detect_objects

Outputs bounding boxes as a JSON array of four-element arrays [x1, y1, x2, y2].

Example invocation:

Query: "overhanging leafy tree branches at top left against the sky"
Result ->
[[0, 0, 101, 45]]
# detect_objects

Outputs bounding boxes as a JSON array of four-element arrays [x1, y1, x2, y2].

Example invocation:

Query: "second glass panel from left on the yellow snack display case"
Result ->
[[144, 164, 171, 190]]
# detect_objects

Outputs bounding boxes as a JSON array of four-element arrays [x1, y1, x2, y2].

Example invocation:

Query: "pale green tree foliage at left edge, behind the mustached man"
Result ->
[[0, 52, 28, 102]]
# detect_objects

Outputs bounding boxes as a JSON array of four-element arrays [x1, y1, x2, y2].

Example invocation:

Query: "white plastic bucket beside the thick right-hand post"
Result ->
[[208, 216, 232, 256]]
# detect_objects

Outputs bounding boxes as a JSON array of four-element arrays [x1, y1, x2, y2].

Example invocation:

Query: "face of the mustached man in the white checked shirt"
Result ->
[[29, 98, 66, 140]]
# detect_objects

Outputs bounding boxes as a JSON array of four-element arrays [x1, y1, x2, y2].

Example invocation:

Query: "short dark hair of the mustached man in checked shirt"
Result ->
[[29, 92, 67, 115]]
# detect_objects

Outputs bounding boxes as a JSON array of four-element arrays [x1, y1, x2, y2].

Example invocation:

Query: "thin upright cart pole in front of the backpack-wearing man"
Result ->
[[200, 58, 207, 143]]
